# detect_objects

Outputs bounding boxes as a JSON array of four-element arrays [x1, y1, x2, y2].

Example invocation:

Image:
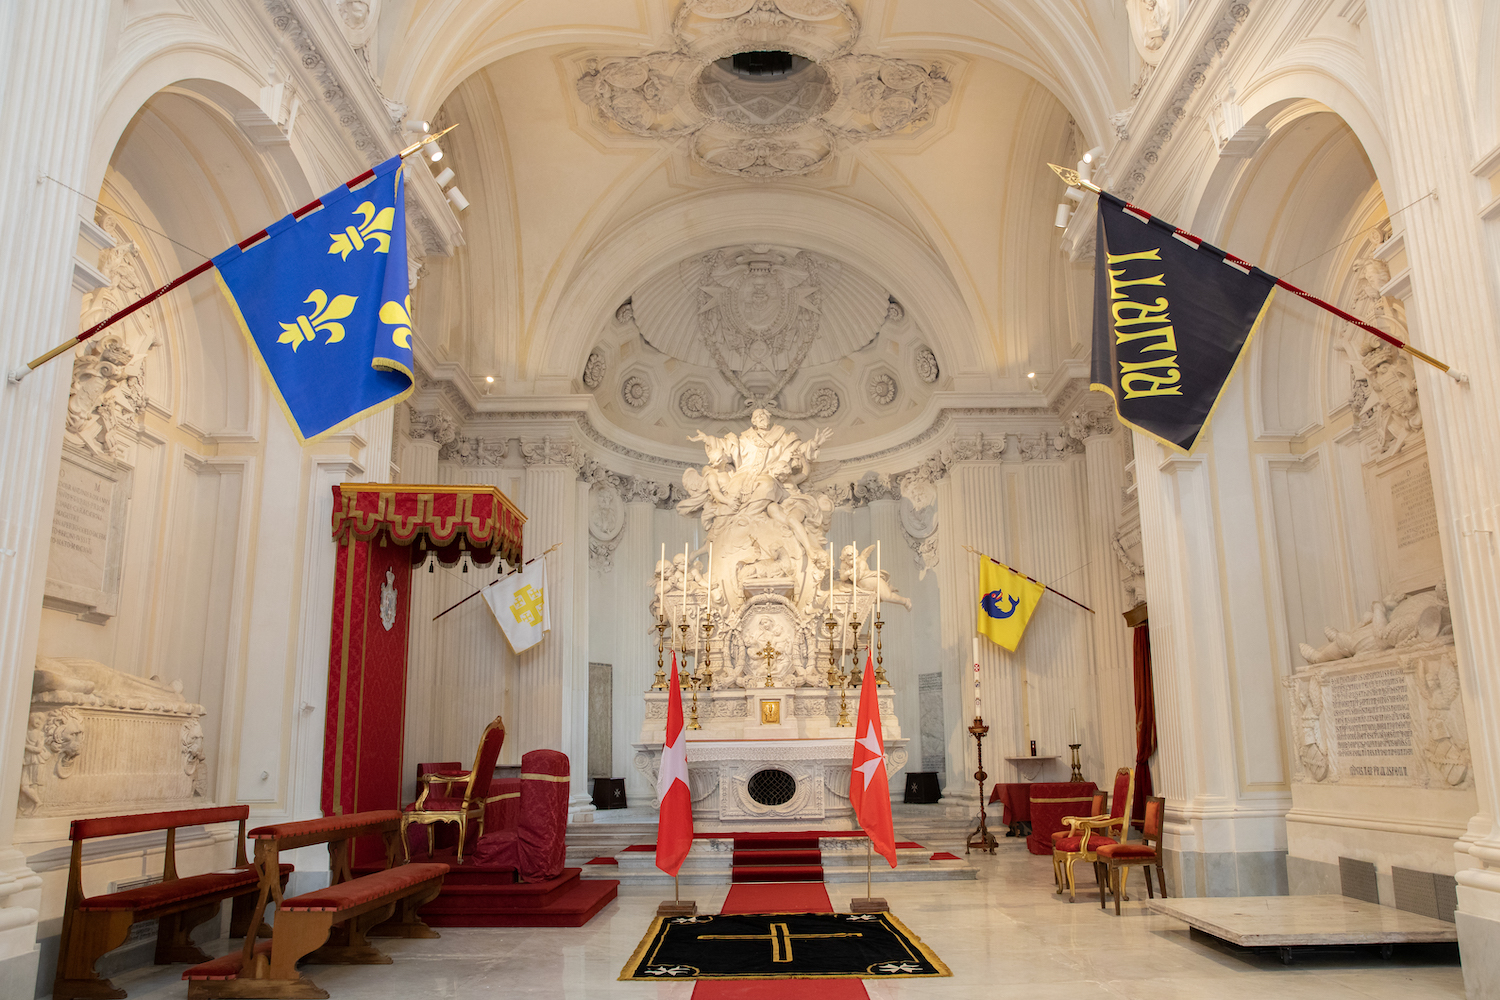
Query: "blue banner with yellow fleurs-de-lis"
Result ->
[[213, 156, 413, 442]]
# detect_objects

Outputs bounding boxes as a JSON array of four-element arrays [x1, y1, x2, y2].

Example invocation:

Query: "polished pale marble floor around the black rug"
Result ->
[[116, 841, 1464, 1000]]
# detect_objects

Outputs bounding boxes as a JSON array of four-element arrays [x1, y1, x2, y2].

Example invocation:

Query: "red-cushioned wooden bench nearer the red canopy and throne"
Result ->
[[183, 810, 449, 1000]]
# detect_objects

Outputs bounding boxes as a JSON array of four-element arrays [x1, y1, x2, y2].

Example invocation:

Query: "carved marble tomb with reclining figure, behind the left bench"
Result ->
[[20, 657, 209, 817]]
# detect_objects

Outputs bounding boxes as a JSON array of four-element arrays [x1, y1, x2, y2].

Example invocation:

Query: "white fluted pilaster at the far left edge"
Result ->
[[0, 0, 111, 984]]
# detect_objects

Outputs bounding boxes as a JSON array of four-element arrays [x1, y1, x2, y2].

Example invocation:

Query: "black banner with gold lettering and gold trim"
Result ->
[[1092, 193, 1277, 451]]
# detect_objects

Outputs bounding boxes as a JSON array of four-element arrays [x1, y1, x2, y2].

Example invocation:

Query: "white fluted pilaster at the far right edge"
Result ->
[[1370, 0, 1500, 971]]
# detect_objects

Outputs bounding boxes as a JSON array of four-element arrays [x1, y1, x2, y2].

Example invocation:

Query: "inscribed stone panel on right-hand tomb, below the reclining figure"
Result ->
[[1331, 667, 1418, 780]]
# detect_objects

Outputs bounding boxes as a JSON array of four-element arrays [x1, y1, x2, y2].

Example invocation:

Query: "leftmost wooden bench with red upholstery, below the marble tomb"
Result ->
[[53, 805, 291, 1000]]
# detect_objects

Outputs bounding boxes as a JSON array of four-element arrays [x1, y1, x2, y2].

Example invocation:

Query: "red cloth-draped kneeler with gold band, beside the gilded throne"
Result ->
[[474, 750, 570, 882]]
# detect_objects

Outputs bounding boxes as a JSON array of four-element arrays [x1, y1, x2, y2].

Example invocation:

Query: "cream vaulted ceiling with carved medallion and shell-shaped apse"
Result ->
[[372, 0, 1139, 442]]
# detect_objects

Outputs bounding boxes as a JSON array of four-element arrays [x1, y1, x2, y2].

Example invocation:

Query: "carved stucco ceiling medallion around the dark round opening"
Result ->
[[576, 0, 953, 180]]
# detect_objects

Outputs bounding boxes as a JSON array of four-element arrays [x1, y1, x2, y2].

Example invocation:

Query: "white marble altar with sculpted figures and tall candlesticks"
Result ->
[[635, 409, 912, 823]]
